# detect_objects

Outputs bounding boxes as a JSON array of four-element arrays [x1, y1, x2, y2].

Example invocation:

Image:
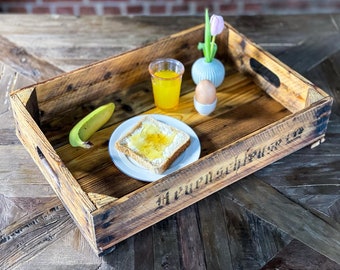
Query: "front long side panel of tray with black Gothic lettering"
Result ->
[[93, 99, 332, 252]]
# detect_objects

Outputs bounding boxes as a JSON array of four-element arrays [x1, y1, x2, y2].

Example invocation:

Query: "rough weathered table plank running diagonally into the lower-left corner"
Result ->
[[0, 199, 74, 269]]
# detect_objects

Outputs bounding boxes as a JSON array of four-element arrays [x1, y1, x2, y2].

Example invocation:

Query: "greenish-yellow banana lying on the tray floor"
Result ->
[[69, 102, 115, 148]]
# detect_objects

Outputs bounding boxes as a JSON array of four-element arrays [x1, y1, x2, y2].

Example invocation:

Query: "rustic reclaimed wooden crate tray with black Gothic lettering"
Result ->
[[11, 23, 332, 255]]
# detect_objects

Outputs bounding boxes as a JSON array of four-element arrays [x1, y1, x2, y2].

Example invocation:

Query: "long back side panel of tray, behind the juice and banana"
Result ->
[[36, 27, 219, 122]]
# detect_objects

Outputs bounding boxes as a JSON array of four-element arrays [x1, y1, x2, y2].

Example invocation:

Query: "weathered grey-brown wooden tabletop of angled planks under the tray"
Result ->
[[0, 14, 340, 270]]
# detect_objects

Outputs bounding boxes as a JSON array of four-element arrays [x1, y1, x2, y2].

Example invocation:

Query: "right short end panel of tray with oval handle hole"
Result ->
[[224, 22, 328, 113]]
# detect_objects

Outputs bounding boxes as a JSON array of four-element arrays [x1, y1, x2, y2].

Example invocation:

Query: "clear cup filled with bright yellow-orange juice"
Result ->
[[149, 58, 184, 110]]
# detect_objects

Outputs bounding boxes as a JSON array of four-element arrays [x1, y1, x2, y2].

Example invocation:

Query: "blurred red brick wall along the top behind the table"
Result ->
[[0, 0, 340, 15]]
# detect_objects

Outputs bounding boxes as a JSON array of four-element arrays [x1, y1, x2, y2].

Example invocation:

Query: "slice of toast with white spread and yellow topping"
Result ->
[[115, 116, 190, 174]]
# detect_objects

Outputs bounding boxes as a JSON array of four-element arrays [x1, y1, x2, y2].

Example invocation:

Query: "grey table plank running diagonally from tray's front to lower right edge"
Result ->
[[222, 176, 340, 263]]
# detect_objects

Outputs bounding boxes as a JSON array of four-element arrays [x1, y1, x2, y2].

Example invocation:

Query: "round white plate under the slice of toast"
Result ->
[[109, 114, 201, 182]]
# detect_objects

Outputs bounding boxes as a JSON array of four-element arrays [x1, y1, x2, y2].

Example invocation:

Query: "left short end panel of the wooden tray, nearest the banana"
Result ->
[[10, 91, 96, 250]]
